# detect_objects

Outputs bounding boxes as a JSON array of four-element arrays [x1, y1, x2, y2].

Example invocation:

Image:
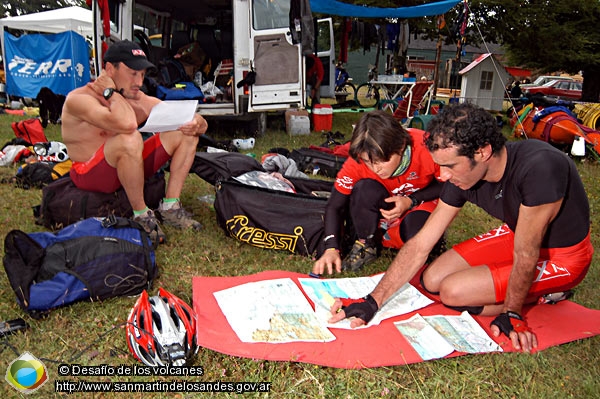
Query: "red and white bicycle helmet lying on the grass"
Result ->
[[127, 288, 198, 366]]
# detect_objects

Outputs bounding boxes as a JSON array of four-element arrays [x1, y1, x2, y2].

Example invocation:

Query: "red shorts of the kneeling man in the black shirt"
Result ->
[[453, 224, 594, 303]]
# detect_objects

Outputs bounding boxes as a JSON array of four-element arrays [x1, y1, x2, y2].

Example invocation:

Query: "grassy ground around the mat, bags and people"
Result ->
[[0, 108, 600, 399]]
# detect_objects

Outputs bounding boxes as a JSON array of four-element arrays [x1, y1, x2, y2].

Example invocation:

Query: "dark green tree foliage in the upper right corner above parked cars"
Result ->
[[452, 0, 600, 102]]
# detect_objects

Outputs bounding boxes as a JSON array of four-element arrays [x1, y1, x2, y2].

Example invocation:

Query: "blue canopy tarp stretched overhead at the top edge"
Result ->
[[310, 0, 462, 18]]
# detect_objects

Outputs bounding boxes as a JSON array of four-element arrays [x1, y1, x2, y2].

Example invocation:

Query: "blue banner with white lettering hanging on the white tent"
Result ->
[[4, 31, 90, 98]]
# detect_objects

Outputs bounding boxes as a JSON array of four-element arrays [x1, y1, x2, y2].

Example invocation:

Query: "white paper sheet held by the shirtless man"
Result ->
[[140, 100, 198, 133]]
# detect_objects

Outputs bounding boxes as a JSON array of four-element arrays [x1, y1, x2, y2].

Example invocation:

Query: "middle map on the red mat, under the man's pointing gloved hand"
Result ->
[[298, 273, 433, 329]]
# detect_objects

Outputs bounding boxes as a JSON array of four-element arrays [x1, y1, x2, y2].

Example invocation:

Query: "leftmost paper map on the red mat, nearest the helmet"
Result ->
[[214, 278, 335, 343]]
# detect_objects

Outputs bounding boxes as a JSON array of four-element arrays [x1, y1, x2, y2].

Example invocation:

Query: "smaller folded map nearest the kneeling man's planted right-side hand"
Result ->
[[394, 312, 502, 360]]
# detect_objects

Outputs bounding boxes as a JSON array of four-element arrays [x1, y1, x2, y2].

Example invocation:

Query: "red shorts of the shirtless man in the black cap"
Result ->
[[69, 134, 171, 193]]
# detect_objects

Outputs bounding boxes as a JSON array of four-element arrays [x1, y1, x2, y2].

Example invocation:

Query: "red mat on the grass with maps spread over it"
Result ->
[[192, 271, 600, 369]]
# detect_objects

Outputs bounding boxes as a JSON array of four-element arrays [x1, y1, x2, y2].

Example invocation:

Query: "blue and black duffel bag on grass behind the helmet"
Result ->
[[3, 216, 157, 317]]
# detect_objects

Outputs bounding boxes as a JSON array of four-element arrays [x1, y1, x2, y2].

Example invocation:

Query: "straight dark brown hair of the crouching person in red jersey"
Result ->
[[349, 111, 412, 162]]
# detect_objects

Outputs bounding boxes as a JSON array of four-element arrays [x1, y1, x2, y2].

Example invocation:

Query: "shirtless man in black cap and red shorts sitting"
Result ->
[[62, 40, 208, 242]]
